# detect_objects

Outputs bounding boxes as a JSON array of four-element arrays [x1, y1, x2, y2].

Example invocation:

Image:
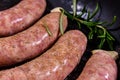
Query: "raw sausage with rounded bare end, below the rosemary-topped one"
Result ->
[[0, 30, 87, 80]]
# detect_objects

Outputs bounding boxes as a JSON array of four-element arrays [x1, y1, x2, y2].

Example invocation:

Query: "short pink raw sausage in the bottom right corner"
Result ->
[[77, 50, 117, 80]]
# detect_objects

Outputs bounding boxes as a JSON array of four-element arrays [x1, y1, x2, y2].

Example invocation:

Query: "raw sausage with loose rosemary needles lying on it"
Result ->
[[0, 12, 67, 66]]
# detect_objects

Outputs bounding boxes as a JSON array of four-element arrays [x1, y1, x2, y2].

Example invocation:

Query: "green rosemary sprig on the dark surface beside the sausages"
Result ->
[[61, 0, 116, 50]]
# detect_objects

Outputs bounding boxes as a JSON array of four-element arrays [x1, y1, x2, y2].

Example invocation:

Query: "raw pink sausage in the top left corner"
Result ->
[[0, 0, 46, 36]]
